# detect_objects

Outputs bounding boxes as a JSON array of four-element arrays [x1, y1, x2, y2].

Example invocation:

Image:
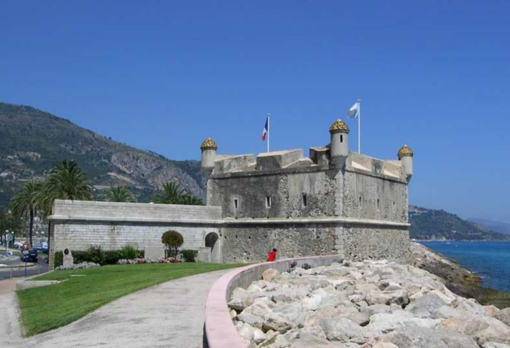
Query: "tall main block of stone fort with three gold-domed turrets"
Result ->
[[201, 121, 413, 262]]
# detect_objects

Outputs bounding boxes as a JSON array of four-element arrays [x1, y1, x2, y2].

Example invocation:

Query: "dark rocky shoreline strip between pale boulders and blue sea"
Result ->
[[408, 240, 510, 309]]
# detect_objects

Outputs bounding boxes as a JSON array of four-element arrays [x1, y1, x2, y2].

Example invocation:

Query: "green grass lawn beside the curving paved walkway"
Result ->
[[17, 263, 246, 336]]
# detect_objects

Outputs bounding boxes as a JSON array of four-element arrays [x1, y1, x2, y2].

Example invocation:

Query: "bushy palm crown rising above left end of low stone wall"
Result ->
[[43, 160, 92, 210]]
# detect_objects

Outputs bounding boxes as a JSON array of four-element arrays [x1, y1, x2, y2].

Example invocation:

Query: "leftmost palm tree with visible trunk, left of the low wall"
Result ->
[[11, 181, 43, 245]]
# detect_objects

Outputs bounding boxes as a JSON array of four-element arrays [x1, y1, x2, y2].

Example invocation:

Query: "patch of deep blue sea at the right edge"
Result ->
[[420, 242, 510, 293]]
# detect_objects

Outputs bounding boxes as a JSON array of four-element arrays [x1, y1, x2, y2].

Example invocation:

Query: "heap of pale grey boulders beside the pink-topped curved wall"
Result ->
[[229, 261, 510, 348]]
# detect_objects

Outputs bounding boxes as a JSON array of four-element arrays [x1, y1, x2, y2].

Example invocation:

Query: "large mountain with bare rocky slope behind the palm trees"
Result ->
[[0, 103, 205, 207]]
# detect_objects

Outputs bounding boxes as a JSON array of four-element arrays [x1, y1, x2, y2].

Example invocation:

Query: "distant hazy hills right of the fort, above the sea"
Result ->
[[409, 205, 510, 240]]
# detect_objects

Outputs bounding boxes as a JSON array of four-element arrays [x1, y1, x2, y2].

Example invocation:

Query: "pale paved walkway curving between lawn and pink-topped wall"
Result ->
[[0, 270, 229, 348]]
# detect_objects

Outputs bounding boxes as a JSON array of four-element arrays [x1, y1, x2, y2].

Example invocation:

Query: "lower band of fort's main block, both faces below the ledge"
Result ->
[[221, 223, 409, 263]]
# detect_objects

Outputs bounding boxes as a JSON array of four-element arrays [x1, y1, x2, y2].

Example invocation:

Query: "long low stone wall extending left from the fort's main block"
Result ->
[[50, 200, 221, 264]]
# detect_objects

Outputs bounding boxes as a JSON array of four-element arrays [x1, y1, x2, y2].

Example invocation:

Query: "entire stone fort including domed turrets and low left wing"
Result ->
[[50, 121, 413, 263]]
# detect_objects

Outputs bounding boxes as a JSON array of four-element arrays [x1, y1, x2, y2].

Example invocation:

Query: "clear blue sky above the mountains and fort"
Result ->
[[0, 0, 510, 222]]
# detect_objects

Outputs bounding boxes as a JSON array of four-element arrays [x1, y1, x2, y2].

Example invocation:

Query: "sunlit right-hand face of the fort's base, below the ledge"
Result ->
[[339, 225, 409, 261]]
